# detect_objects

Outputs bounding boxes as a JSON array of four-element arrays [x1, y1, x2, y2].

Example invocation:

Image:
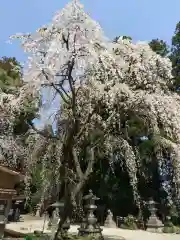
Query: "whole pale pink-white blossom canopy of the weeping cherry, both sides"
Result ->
[[9, 1, 180, 202]]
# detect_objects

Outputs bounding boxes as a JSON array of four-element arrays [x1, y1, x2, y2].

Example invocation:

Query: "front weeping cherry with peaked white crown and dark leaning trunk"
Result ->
[[11, 1, 118, 238]]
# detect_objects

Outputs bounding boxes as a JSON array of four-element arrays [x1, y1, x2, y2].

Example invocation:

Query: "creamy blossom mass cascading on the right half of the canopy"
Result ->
[[80, 39, 180, 199]]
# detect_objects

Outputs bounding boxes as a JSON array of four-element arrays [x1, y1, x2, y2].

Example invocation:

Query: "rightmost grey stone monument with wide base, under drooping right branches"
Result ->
[[146, 199, 164, 232]]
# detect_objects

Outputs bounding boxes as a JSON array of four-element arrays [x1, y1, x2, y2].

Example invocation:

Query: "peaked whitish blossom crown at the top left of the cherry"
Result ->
[[11, 1, 108, 87]]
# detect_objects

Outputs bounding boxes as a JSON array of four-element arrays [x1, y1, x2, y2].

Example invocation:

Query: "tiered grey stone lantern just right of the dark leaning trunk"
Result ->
[[78, 190, 103, 239]]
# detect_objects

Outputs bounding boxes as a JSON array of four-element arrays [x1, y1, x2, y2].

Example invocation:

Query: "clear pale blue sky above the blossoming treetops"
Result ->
[[0, 0, 180, 61]]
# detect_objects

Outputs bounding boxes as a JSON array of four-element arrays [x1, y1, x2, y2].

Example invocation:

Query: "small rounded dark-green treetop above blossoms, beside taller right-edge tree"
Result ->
[[149, 38, 169, 57]]
